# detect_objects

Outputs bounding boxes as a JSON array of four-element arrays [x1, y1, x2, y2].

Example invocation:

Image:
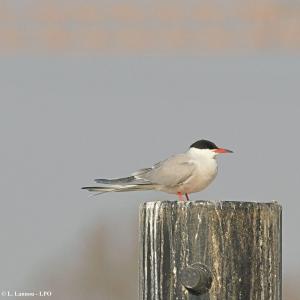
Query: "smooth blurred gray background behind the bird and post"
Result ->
[[0, 54, 300, 299]]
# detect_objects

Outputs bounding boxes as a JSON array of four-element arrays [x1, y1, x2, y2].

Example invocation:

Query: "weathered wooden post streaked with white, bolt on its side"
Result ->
[[139, 201, 281, 300]]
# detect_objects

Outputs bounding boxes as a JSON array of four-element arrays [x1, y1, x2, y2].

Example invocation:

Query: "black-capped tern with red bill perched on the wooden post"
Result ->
[[82, 139, 233, 201]]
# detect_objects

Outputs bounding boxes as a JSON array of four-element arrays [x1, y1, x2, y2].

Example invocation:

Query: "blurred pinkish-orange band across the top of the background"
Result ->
[[0, 0, 300, 55]]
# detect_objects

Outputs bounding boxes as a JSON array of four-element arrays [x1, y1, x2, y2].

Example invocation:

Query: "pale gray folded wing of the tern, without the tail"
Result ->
[[132, 154, 195, 187]]
